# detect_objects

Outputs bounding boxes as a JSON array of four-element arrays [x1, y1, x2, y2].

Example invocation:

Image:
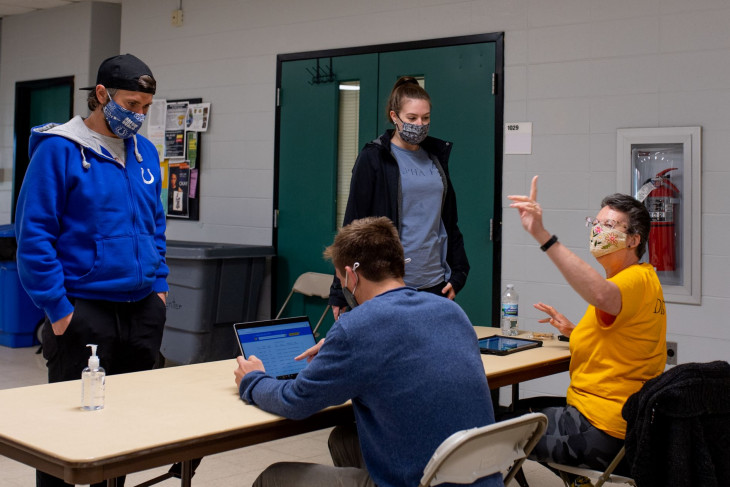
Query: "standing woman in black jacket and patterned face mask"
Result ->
[[329, 76, 469, 319]]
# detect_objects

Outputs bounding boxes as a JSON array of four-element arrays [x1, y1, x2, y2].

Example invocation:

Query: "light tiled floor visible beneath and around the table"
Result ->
[[0, 346, 616, 487]]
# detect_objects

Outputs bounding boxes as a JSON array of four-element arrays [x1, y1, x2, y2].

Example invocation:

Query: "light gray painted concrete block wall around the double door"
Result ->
[[0, 0, 730, 394]]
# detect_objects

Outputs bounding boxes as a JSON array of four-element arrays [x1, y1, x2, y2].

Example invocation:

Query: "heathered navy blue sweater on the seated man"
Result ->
[[240, 288, 503, 487]]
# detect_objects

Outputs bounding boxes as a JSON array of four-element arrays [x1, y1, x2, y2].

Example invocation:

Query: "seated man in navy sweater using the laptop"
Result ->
[[235, 217, 504, 487]]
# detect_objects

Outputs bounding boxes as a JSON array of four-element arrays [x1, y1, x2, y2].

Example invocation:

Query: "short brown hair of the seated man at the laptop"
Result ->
[[324, 216, 405, 282]]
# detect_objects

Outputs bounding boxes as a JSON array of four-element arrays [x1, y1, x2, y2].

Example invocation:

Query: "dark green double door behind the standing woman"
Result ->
[[274, 42, 496, 335]]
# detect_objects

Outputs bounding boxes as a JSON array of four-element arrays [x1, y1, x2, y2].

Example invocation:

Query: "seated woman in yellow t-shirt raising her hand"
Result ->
[[508, 176, 667, 469]]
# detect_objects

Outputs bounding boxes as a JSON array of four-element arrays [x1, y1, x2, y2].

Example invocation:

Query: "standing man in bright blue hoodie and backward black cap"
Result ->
[[16, 54, 168, 485]]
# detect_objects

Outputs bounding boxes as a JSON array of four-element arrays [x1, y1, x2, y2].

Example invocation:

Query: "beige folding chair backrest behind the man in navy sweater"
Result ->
[[421, 413, 547, 486]]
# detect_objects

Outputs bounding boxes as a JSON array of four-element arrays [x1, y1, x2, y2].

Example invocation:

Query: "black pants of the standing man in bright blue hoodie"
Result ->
[[36, 293, 166, 487]]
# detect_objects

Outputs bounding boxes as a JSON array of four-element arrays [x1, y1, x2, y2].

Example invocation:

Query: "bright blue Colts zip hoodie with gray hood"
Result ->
[[16, 117, 169, 322]]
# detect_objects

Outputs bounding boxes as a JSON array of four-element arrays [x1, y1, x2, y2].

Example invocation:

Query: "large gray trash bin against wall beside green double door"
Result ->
[[160, 240, 274, 364]]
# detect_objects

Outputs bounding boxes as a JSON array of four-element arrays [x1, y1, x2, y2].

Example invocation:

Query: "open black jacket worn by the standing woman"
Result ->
[[329, 130, 469, 306]]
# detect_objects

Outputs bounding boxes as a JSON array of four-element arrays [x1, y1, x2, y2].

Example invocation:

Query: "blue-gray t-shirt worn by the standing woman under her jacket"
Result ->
[[391, 144, 451, 289]]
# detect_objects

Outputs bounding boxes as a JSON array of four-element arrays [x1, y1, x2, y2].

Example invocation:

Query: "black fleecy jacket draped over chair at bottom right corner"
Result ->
[[622, 361, 730, 487]]
